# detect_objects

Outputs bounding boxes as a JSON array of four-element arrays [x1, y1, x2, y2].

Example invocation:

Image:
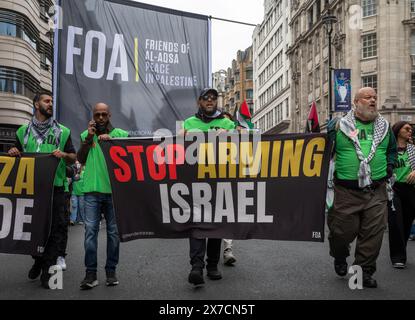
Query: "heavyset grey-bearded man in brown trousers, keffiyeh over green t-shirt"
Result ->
[[327, 87, 396, 288]]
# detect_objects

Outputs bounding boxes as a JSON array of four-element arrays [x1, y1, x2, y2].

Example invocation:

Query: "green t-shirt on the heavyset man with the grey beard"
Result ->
[[335, 120, 390, 180]]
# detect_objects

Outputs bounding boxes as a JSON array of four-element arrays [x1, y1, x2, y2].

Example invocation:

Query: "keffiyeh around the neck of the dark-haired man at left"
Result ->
[[23, 117, 62, 152]]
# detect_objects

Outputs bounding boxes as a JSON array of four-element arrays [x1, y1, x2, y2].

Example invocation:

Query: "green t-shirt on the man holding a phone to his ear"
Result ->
[[81, 128, 128, 194]]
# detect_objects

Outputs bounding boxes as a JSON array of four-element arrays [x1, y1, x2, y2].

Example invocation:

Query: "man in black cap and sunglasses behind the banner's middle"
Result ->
[[183, 88, 235, 285]]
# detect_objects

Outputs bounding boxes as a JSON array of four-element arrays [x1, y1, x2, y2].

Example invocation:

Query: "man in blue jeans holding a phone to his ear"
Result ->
[[78, 103, 128, 290]]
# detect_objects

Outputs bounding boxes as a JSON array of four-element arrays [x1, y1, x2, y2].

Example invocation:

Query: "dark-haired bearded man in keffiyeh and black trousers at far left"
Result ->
[[9, 92, 76, 289]]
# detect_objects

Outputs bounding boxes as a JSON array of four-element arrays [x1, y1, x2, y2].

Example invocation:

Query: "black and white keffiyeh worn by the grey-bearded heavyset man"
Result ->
[[339, 110, 389, 188]]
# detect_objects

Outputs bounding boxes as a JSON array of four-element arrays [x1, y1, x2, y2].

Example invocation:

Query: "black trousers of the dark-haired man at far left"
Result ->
[[33, 187, 69, 272]]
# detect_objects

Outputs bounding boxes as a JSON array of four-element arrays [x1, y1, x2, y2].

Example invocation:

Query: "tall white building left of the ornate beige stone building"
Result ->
[[252, 0, 291, 133]]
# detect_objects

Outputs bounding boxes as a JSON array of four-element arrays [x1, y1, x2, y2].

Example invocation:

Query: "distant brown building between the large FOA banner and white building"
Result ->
[[223, 46, 254, 115]]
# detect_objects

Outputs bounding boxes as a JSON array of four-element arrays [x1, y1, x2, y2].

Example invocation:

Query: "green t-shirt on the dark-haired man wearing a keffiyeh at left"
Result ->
[[16, 124, 71, 188]]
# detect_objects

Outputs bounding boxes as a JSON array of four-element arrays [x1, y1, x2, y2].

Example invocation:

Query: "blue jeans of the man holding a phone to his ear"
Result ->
[[84, 193, 120, 272]]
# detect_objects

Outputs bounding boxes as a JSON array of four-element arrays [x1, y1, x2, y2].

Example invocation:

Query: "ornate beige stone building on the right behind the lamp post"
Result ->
[[288, 0, 415, 132]]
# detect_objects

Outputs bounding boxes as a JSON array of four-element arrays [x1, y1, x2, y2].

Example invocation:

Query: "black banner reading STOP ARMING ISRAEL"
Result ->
[[101, 133, 330, 242]]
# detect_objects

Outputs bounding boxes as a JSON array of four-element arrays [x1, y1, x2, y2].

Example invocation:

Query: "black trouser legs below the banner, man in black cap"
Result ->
[[189, 238, 222, 269]]
